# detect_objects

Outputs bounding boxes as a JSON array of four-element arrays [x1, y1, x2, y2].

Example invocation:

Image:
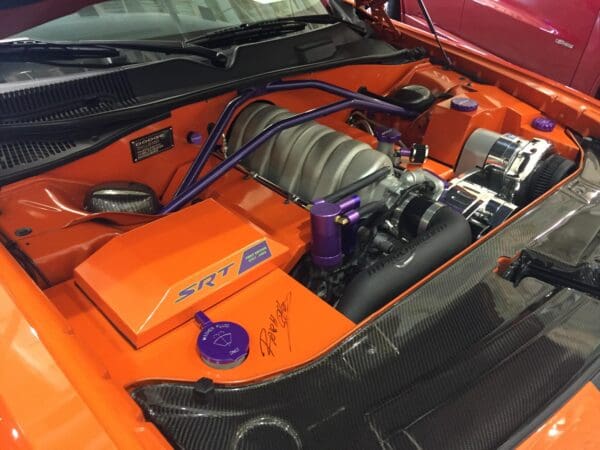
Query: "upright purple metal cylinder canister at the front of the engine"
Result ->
[[310, 202, 343, 269]]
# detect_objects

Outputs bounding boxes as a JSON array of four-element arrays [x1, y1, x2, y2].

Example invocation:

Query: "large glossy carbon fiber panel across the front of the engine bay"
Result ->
[[132, 149, 600, 450]]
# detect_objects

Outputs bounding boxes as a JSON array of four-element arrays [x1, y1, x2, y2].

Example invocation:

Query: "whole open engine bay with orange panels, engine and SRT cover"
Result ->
[[0, 61, 581, 386]]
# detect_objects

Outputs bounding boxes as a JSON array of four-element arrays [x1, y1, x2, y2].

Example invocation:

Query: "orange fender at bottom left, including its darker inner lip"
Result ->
[[0, 248, 169, 450]]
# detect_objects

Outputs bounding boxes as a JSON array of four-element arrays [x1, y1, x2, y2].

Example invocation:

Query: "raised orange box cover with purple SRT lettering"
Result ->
[[75, 199, 288, 347]]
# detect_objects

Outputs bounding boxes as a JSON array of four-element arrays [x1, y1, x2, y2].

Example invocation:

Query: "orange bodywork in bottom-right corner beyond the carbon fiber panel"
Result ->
[[517, 383, 600, 450]]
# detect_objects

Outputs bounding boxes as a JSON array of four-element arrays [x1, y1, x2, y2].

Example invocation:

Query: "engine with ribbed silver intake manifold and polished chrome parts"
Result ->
[[221, 96, 575, 322]]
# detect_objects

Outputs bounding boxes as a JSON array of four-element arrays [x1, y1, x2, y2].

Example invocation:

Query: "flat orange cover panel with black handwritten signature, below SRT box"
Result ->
[[45, 269, 356, 386]]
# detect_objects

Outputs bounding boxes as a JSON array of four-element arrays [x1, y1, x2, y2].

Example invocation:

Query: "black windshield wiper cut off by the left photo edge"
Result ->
[[0, 39, 228, 67]]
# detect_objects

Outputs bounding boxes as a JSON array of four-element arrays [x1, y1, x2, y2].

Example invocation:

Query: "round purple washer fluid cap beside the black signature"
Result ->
[[195, 312, 250, 370]]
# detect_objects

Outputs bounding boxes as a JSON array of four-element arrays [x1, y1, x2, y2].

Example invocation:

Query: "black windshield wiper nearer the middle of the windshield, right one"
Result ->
[[186, 14, 364, 47]]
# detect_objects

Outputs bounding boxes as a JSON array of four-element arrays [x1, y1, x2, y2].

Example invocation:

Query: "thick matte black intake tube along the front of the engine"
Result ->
[[337, 207, 472, 322]]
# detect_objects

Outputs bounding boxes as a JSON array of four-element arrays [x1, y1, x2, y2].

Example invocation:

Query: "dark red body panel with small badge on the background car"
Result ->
[[458, 0, 600, 84]]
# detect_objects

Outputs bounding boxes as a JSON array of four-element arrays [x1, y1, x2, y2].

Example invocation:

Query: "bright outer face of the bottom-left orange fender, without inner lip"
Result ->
[[0, 284, 116, 450]]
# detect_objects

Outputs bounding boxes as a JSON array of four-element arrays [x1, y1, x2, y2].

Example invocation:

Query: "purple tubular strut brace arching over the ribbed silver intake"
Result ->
[[161, 80, 417, 214]]
